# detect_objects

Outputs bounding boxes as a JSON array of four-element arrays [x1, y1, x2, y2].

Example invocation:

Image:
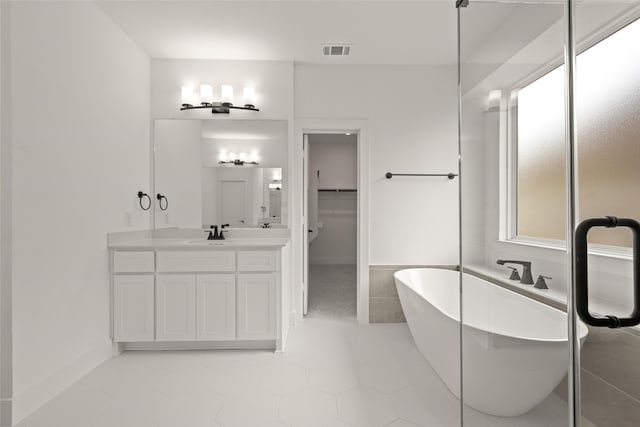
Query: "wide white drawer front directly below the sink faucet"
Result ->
[[156, 251, 236, 273]]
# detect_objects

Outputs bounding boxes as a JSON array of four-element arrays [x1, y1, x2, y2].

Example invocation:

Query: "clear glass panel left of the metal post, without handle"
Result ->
[[458, 0, 586, 426]]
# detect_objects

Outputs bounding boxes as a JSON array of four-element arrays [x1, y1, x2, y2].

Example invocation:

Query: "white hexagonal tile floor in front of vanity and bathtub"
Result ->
[[19, 319, 567, 427]]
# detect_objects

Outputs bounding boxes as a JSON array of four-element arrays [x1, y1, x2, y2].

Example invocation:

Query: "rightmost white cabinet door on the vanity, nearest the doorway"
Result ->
[[237, 273, 278, 340]]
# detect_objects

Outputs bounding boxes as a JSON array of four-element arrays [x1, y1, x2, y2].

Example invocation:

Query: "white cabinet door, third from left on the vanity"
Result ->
[[196, 274, 236, 341]]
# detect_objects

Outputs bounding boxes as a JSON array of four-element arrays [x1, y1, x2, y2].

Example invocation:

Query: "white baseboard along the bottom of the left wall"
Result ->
[[11, 340, 113, 425]]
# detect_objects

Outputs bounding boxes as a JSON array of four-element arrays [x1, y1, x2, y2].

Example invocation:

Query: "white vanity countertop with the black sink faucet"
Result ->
[[108, 229, 291, 250]]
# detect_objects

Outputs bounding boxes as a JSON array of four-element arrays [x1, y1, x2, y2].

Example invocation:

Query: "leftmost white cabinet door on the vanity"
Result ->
[[113, 274, 154, 342]]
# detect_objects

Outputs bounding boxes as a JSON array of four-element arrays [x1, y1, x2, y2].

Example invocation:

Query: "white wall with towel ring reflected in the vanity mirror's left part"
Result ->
[[152, 120, 203, 228]]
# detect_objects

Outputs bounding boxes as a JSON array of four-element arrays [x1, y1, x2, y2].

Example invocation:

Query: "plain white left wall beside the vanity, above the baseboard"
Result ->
[[9, 2, 150, 419]]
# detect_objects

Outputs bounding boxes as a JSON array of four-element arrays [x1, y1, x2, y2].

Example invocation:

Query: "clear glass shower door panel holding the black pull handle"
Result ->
[[572, 0, 640, 427]]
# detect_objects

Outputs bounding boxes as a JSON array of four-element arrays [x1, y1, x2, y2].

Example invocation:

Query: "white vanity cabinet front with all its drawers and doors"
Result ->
[[113, 248, 281, 348]]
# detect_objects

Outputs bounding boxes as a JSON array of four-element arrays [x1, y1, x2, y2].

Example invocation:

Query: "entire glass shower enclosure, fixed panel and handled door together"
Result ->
[[458, 0, 640, 426]]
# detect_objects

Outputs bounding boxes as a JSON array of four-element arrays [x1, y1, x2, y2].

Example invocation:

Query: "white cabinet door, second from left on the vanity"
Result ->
[[156, 274, 196, 341]]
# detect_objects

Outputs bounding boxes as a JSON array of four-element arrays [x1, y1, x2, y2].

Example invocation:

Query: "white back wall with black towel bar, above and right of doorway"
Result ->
[[293, 65, 458, 265]]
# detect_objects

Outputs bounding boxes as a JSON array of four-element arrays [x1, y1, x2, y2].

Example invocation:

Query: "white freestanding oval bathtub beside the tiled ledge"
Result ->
[[394, 268, 588, 417]]
